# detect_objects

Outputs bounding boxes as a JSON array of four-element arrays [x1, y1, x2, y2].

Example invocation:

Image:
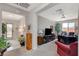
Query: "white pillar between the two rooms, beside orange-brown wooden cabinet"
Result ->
[[28, 12, 38, 49]]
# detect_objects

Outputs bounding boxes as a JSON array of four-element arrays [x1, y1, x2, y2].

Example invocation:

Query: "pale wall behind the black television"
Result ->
[[38, 16, 55, 32]]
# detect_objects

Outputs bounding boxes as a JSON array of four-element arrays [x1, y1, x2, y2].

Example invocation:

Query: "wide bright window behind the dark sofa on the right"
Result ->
[[62, 22, 75, 32]]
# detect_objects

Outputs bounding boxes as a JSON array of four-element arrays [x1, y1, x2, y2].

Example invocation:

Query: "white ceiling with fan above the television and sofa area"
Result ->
[[38, 3, 79, 21]]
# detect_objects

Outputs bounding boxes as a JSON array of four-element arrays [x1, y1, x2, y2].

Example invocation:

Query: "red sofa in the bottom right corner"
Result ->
[[55, 41, 78, 56]]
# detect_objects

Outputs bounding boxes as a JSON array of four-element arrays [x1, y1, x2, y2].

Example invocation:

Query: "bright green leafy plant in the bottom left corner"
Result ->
[[0, 37, 10, 56]]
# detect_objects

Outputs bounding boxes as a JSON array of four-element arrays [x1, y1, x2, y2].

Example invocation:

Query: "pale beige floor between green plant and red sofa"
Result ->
[[4, 41, 58, 56]]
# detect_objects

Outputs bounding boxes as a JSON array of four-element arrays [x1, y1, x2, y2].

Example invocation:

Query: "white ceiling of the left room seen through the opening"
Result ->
[[2, 11, 24, 20]]
